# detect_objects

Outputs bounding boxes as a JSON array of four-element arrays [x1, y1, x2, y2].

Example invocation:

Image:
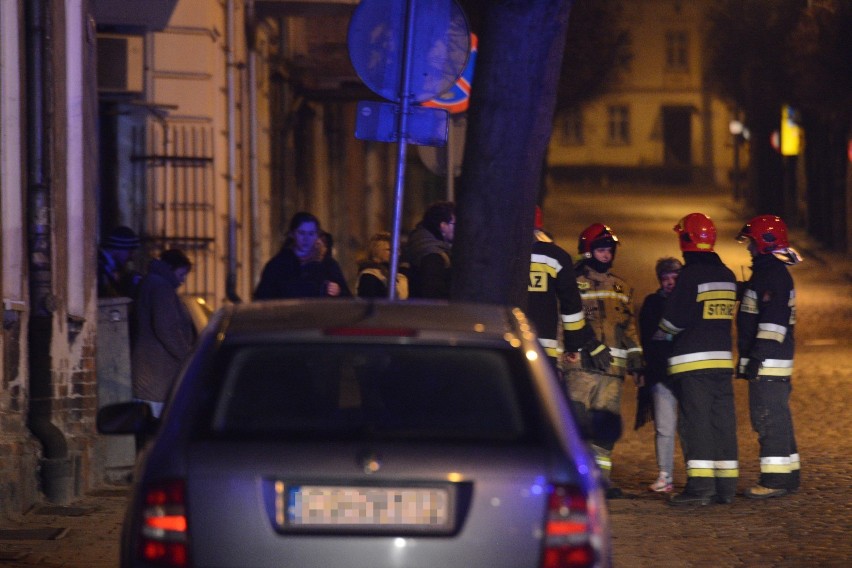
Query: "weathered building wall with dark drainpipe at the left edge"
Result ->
[[0, 0, 101, 513]]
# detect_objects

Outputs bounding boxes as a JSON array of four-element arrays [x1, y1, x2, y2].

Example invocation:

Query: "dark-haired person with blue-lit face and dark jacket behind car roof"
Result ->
[[254, 211, 352, 300]]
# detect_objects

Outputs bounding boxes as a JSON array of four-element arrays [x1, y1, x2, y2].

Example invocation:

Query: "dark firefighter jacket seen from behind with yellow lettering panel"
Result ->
[[660, 252, 737, 378]]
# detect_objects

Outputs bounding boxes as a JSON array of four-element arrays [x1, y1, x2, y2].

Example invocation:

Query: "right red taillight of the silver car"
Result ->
[[541, 485, 597, 568]]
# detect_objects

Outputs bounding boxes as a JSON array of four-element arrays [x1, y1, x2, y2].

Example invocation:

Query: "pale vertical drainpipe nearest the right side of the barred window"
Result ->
[[225, 0, 241, 302]]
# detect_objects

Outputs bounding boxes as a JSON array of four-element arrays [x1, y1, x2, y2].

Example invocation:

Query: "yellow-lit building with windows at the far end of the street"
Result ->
[[549, 0, 745, 185]]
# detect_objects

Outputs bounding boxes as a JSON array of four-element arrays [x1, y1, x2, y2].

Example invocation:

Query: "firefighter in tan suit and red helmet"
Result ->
[[566, 223, 642, 498]]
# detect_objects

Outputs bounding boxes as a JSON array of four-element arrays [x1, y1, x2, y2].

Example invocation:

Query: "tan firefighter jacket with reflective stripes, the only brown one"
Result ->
[[575, 262, 642, 376]]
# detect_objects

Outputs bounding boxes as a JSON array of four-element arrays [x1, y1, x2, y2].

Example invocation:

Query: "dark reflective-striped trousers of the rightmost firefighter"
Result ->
[[748, 377, 799, 491]]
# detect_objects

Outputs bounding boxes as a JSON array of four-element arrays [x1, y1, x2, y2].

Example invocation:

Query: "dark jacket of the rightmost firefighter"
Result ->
[[737, 254, 796, 378]]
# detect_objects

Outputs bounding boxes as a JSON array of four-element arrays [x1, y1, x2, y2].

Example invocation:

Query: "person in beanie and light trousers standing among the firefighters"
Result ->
[[634, 257, 683, 493]]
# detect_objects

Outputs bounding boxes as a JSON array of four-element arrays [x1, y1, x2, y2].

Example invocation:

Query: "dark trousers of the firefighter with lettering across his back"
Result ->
[[674, 370, 739, 498]]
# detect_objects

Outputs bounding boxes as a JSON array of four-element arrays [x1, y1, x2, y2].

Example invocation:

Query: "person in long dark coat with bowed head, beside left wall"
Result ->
[[131, 249, 195, 416]]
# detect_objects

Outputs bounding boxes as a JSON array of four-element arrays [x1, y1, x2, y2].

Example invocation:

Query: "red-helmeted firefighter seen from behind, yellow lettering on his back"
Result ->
[[660, 213, 739, 505]]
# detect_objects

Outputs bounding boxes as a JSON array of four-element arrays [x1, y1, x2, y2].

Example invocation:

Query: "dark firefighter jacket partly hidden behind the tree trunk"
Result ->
[[527, 230, 586, 358]]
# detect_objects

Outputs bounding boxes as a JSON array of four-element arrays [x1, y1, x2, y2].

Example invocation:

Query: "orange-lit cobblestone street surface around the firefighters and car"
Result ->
[[0, 184, 852, 568]]
